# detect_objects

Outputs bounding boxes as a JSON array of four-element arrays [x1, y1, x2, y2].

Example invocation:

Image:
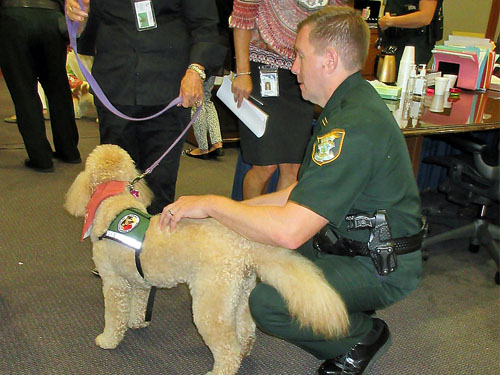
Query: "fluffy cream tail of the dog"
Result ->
[[253, 247, 349, 338]]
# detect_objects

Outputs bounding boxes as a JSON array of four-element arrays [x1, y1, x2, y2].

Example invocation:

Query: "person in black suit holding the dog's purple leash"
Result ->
[[66, 0, 226, 214]]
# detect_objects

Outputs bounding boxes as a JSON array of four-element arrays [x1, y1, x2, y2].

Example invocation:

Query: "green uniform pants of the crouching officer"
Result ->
[[250, 241, 422, 360]]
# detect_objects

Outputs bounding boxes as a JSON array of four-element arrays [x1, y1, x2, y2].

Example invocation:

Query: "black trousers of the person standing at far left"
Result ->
[[0, 8, 80, 168]]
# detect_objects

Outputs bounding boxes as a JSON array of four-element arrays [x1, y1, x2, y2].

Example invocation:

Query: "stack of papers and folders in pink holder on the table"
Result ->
[[432, 34, 496, 90]]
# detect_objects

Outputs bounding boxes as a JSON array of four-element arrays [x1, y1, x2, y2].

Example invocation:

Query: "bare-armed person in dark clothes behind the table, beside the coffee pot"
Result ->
[[379, 0, 443, 67]]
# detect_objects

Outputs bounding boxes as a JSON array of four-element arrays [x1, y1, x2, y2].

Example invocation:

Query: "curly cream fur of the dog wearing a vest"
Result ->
[[65, 145, 349, 375]]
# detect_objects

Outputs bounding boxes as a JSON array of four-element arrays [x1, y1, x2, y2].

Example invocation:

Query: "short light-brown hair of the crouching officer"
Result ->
[[298, 6, 370, 71]]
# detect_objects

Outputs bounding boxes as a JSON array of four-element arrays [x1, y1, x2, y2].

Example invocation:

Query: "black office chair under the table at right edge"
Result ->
[[422, 135, 500, 285]]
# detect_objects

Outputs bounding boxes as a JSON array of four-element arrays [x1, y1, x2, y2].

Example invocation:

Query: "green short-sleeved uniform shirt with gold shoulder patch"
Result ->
[[290, 72, 421, 242]]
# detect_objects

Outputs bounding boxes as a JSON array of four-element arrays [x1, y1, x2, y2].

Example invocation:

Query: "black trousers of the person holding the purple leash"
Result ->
[[96, 100, 190, 215]]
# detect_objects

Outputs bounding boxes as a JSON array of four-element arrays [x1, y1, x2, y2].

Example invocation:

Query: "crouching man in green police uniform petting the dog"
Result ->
[[160, 7, 421, 375]]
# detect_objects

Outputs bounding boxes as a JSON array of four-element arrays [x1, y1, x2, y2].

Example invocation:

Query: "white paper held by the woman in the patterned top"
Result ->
[[217, 76, 269, 138]]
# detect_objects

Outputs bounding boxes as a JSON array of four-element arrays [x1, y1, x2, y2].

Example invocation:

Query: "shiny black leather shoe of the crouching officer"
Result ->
[[318, 318, 391, 375]]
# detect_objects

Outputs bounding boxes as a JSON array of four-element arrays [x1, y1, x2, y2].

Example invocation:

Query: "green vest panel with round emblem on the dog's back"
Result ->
[[100, 208, 152, 250]]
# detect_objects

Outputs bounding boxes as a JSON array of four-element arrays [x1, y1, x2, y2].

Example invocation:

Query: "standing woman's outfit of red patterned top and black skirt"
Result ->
[[229, 0, 343, 166]]
